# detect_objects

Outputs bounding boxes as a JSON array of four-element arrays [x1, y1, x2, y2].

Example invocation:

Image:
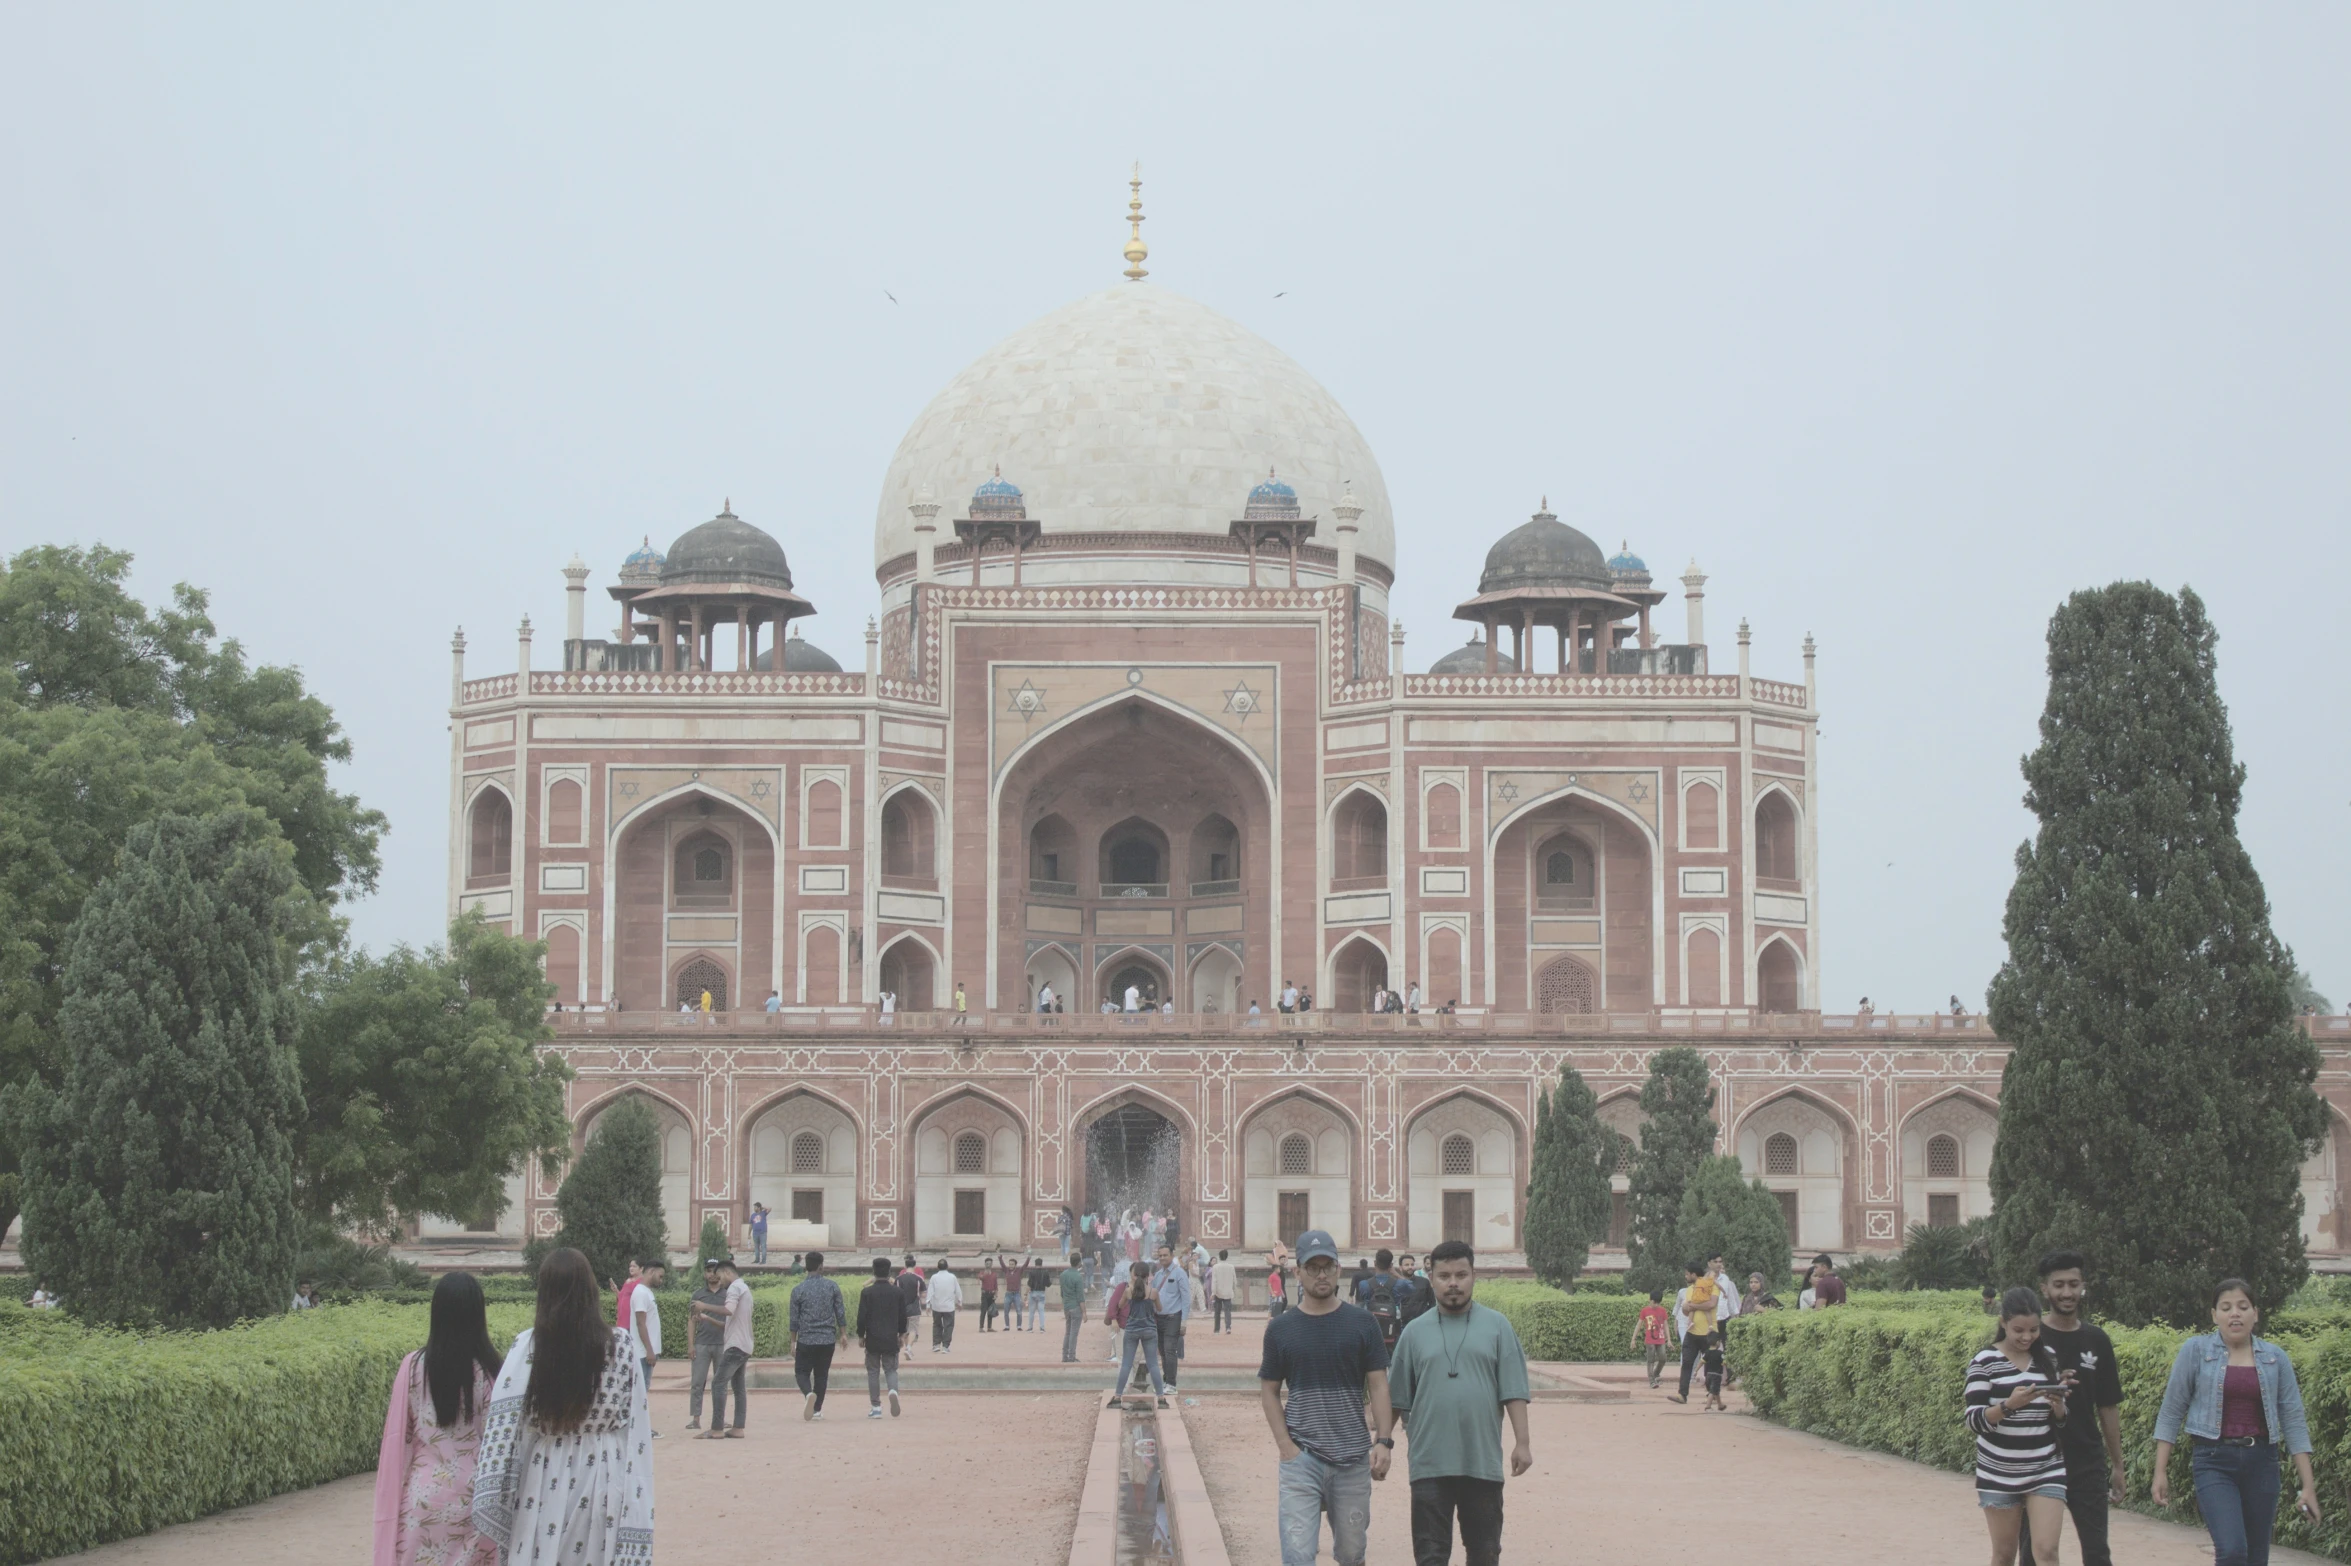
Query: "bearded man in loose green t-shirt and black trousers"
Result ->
[[1380, 1239, 1535, 1566]]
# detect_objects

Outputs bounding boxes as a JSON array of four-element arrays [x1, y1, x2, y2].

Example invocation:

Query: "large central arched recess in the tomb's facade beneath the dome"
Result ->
[[994, 694, 1277, 1013]]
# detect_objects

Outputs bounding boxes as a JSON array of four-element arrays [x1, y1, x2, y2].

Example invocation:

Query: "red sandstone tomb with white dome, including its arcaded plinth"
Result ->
[[441, 176, 2351, 1265]]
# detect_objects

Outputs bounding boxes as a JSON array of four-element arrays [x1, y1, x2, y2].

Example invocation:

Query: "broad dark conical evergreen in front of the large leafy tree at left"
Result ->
[[7, 811, 308, 1326]]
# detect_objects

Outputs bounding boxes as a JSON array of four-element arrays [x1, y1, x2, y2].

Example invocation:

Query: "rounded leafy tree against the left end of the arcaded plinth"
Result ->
[[296, 912, 571, 1234]]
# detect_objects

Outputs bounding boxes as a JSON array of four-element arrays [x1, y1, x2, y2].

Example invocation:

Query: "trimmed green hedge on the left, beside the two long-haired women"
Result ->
[[0, 1303, 531, 1566]]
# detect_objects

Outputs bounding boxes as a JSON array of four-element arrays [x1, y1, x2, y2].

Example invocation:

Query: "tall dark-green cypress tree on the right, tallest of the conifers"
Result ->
[[1991, 583, 2325, 1326]]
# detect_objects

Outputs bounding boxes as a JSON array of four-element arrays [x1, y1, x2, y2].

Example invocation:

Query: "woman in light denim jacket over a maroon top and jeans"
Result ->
[[2154, 1277, 2318, 1566]]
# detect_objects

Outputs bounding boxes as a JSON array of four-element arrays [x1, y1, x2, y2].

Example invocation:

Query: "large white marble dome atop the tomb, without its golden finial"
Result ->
[[875, 282, 1396, 569]]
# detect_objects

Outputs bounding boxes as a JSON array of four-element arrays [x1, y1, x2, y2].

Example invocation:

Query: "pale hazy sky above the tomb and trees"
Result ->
[[0, 2, 2351, 1011]]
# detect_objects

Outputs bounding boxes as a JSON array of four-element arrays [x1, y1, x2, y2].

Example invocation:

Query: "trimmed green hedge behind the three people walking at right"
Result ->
[[1730, 1291, 2351, 1561]]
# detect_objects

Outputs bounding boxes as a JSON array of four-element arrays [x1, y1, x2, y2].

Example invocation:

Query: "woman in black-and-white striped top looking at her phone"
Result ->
[[1968, 1289, 2064, 1566]]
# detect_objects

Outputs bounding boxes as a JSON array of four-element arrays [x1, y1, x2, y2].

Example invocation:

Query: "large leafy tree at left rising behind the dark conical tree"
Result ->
[[0, 546, 383, 1230]]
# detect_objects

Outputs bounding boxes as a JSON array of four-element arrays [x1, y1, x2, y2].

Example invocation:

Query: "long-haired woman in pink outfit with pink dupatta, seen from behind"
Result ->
[[376, 1272, 501, 1566]]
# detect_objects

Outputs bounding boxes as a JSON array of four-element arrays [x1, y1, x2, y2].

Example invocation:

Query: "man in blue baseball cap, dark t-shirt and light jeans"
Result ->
[[1258, 1230, 1396, 1566]]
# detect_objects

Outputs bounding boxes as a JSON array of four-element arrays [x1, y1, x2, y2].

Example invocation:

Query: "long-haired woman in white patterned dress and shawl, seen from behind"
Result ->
[[473, 1246, 654, 1566]]
